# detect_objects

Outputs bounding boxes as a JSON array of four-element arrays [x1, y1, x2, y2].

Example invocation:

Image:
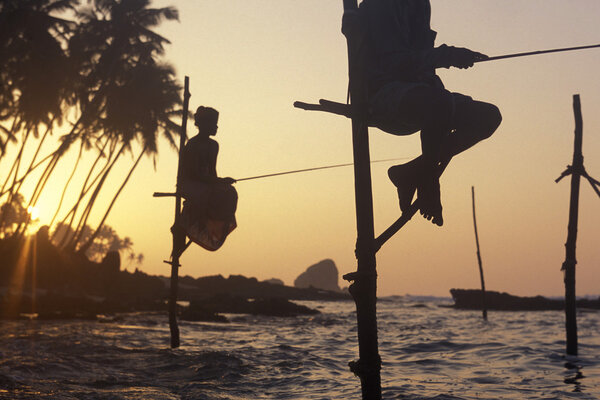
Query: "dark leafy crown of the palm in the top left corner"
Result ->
[[0, 0, 78, 125]]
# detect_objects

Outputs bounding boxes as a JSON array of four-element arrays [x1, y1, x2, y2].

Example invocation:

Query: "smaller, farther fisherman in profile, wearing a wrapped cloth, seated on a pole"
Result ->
[[180, 106, 238, 251]]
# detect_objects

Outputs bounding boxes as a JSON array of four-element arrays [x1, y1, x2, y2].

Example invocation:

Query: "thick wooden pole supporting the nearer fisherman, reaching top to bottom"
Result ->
[[342, 0, 381, 400]]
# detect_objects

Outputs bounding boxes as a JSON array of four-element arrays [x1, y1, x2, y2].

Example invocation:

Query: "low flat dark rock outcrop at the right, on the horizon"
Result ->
[[450, 289, 600, 311]]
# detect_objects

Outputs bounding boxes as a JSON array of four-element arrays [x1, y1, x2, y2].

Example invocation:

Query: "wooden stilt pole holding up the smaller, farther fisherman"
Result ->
[[169, 76, 190, 348]]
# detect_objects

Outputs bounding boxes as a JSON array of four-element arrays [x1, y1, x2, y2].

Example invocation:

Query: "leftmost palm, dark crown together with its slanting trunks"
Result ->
[[0, 0, 78, 230]]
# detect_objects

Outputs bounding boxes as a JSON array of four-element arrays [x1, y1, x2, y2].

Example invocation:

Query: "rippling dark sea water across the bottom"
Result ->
[[0, 297, 600, 400]]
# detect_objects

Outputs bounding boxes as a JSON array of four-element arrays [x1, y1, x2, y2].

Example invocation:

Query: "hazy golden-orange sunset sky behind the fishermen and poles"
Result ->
[[2, 0, 600, 296]]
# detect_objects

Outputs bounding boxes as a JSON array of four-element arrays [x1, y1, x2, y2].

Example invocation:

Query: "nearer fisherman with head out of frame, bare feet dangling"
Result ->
[[360, 0, 502, 226]]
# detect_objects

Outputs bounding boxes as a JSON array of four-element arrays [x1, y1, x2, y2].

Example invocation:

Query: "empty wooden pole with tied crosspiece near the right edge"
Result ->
[[562, 94, 583, 355]]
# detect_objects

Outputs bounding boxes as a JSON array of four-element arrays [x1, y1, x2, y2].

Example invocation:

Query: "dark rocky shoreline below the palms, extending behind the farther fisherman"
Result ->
[[0, 233, 350, 320]]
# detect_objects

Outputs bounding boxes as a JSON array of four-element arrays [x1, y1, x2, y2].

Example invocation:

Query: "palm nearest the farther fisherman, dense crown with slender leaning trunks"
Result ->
[[63, 0, 181, 248]]
